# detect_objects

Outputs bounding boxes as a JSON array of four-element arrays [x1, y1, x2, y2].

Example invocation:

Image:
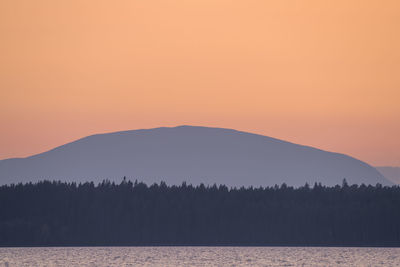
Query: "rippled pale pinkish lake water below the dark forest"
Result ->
[[0, 247, 400, 266]]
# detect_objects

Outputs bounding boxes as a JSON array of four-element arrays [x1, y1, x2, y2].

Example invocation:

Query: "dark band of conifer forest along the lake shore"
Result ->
[[0, 179, 400, 246]]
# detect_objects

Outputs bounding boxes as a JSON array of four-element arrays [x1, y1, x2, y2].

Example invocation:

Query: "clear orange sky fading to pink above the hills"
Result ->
[[0, 0, 400, 168]]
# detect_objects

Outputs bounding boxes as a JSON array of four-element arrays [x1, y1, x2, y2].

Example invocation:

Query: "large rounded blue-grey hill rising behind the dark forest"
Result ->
[[0, 126, 391, 186]]
